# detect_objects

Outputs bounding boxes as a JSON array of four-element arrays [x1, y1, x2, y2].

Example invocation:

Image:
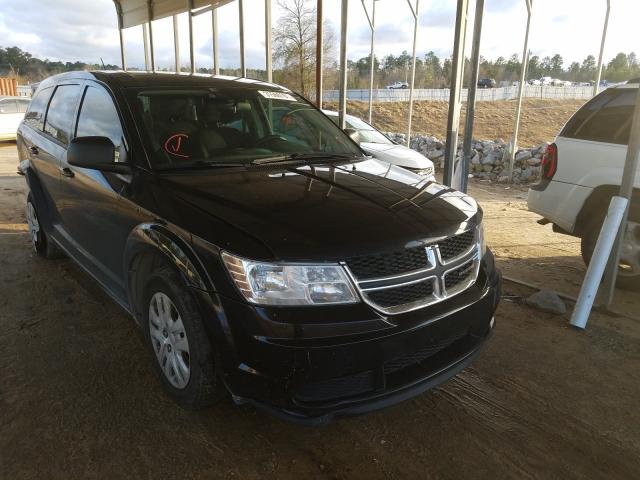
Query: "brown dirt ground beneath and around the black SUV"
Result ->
[[0, 144, 640, 480]]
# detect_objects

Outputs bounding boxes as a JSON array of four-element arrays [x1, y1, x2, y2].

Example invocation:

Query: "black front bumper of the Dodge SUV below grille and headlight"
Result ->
[[198, 253, 501, 424]]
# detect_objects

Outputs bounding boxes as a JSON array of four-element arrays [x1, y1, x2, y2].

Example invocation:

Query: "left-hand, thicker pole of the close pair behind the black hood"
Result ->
[[443, 0, 469, 186]]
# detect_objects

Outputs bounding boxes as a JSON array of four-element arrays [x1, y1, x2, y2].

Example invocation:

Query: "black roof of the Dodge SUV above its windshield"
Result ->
[[39, 70, 290, 92]]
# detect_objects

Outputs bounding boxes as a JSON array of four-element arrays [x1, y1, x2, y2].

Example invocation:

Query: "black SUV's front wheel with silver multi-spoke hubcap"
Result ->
[[143, 266, 226, 409]]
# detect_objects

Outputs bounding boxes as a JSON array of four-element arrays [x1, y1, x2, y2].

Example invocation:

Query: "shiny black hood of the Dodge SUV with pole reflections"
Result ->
[[154, 160, 481, 261]]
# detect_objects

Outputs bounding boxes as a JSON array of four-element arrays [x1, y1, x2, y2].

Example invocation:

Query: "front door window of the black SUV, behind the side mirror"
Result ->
[[76, 87, 123, 153]]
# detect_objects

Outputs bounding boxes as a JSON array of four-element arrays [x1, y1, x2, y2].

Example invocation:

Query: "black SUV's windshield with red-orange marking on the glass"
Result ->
[[137, 88, 362, 169]]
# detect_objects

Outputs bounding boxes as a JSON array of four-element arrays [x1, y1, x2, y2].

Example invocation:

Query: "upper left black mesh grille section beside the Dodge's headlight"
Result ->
[[347, 247, 429, 280]]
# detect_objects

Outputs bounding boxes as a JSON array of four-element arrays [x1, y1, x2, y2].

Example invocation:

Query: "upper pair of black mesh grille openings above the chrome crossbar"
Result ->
[[347, 230, 474, 280]]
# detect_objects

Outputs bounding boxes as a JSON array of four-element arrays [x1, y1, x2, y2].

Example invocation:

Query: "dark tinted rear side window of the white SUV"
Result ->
[[560, 88, 637, 145]]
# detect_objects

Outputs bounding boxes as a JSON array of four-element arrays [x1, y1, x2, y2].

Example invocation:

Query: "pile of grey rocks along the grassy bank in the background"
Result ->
[[387, 133, 547, 184]]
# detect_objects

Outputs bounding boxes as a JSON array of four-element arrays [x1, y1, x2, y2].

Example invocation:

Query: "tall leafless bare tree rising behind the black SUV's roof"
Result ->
[[273, 0, 334, 95]]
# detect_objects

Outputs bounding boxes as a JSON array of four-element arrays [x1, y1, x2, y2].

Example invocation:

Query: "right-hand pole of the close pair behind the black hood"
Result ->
[[460, 0, 484, 192]]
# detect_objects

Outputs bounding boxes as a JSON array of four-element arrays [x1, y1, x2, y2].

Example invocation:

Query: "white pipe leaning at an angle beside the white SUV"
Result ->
[[571, 197, 629, 328]]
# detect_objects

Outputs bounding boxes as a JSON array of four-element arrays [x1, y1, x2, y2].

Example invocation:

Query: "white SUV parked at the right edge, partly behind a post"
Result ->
[[528, 79, 640, 291]]
